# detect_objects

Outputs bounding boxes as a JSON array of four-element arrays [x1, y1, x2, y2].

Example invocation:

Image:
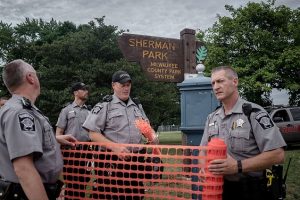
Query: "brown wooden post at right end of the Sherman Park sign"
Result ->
[[180, 29, 197, 74]]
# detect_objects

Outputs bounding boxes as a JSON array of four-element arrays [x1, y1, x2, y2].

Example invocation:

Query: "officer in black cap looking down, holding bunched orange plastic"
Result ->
[[83, 71, 148, 199]]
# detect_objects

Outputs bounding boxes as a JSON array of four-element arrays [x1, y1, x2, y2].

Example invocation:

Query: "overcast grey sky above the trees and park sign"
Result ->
[[0, 0, 300, 104]]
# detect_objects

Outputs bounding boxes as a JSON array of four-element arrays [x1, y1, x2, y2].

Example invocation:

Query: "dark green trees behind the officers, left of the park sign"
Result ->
[[0, 17, 180, 128]]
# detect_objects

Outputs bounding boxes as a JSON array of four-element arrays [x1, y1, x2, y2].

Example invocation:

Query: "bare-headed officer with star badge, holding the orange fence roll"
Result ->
[[201, 66, 286, 200]]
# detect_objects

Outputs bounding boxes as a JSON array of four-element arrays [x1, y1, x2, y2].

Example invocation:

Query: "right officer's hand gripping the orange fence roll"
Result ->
[[208, 155, 237, 175]]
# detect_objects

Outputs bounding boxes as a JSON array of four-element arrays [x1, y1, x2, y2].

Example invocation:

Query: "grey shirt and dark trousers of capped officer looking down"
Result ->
[[83, 95, 148, 200]]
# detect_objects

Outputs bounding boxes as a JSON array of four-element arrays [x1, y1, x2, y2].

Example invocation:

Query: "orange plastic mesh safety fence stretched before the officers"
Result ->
[[61, 139, 226, 200]]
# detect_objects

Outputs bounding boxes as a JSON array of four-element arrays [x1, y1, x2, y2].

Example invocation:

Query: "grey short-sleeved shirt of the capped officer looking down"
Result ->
[[83, 95, 148, 144]]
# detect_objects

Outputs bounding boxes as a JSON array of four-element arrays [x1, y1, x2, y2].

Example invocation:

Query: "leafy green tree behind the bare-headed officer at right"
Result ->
[[204, 0, 300, 106]]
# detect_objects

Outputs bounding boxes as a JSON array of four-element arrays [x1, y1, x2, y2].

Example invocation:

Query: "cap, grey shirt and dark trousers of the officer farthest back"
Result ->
[[56, 82, 92, 199]]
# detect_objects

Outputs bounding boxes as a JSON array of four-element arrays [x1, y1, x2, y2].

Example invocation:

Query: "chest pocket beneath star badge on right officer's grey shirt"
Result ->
[[229, 129, 250, 152]]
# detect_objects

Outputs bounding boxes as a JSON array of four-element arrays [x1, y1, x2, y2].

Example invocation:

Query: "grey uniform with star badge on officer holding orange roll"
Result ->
[[200, 98, 286, 198]]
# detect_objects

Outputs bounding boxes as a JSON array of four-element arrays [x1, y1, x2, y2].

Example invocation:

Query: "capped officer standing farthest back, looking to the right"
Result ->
[[56, 82, 91, 198]]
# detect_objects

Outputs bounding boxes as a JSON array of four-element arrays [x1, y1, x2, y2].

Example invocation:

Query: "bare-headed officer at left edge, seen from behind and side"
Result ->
[[0, 60, 72, 200]]
